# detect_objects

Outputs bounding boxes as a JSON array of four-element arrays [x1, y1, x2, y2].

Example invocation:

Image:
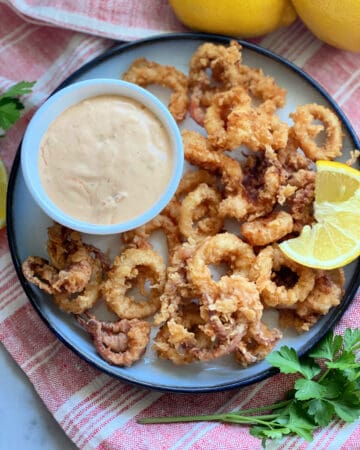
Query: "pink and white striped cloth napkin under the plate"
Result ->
[[0, 0, 360, 450]]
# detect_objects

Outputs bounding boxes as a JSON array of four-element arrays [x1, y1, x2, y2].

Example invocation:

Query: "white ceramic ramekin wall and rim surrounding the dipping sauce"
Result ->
[[21, 78, 184, 234]]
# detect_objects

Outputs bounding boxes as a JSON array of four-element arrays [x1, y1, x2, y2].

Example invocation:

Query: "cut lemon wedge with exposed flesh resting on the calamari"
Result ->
[[280, 161, 360, 269]]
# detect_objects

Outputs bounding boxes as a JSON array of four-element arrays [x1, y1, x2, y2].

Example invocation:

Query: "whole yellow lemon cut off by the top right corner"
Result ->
[[293, 0, 360, 52]]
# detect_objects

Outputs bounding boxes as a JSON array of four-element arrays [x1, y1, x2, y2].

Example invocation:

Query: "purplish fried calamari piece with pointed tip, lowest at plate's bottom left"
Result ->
[[77, 315, 151, 367]]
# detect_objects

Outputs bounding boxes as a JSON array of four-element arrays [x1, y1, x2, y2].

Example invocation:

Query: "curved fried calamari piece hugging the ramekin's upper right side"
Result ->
[[122, 58, 188, 122]]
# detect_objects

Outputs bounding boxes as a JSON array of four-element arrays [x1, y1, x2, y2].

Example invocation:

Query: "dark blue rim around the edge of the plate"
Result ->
[[6, 33, 360, 394]]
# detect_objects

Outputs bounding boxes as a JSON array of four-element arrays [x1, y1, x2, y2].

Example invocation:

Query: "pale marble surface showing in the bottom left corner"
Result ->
[[0, 343, 77, 450]]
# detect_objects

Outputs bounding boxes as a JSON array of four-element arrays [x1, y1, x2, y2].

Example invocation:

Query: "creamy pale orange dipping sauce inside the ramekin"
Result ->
[[39, 95, 173, 225]]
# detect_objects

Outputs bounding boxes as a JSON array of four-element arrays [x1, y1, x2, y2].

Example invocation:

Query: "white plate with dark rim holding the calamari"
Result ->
[[7, 34, 360, 392]]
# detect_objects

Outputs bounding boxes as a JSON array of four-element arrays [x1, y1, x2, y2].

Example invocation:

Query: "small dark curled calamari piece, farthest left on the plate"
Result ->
[[22, 256, 59, 294]]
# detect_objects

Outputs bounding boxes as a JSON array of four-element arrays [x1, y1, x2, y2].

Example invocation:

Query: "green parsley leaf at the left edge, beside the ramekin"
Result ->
[[0, 81, 35, 137]]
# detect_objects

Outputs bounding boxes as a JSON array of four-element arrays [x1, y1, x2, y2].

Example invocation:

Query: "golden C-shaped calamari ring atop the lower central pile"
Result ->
[[188, 233, 255, 298]]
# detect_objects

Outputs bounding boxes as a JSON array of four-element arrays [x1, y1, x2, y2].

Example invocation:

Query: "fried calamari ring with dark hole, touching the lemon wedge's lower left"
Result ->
[[251, 244, 315, 309]]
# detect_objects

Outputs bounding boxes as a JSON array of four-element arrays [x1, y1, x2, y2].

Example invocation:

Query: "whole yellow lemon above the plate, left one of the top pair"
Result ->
[[169, 0, 296, 37]]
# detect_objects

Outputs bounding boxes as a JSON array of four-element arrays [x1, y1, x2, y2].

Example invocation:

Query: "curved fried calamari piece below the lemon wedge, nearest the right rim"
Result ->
[[279, 269, 345, 333]]
